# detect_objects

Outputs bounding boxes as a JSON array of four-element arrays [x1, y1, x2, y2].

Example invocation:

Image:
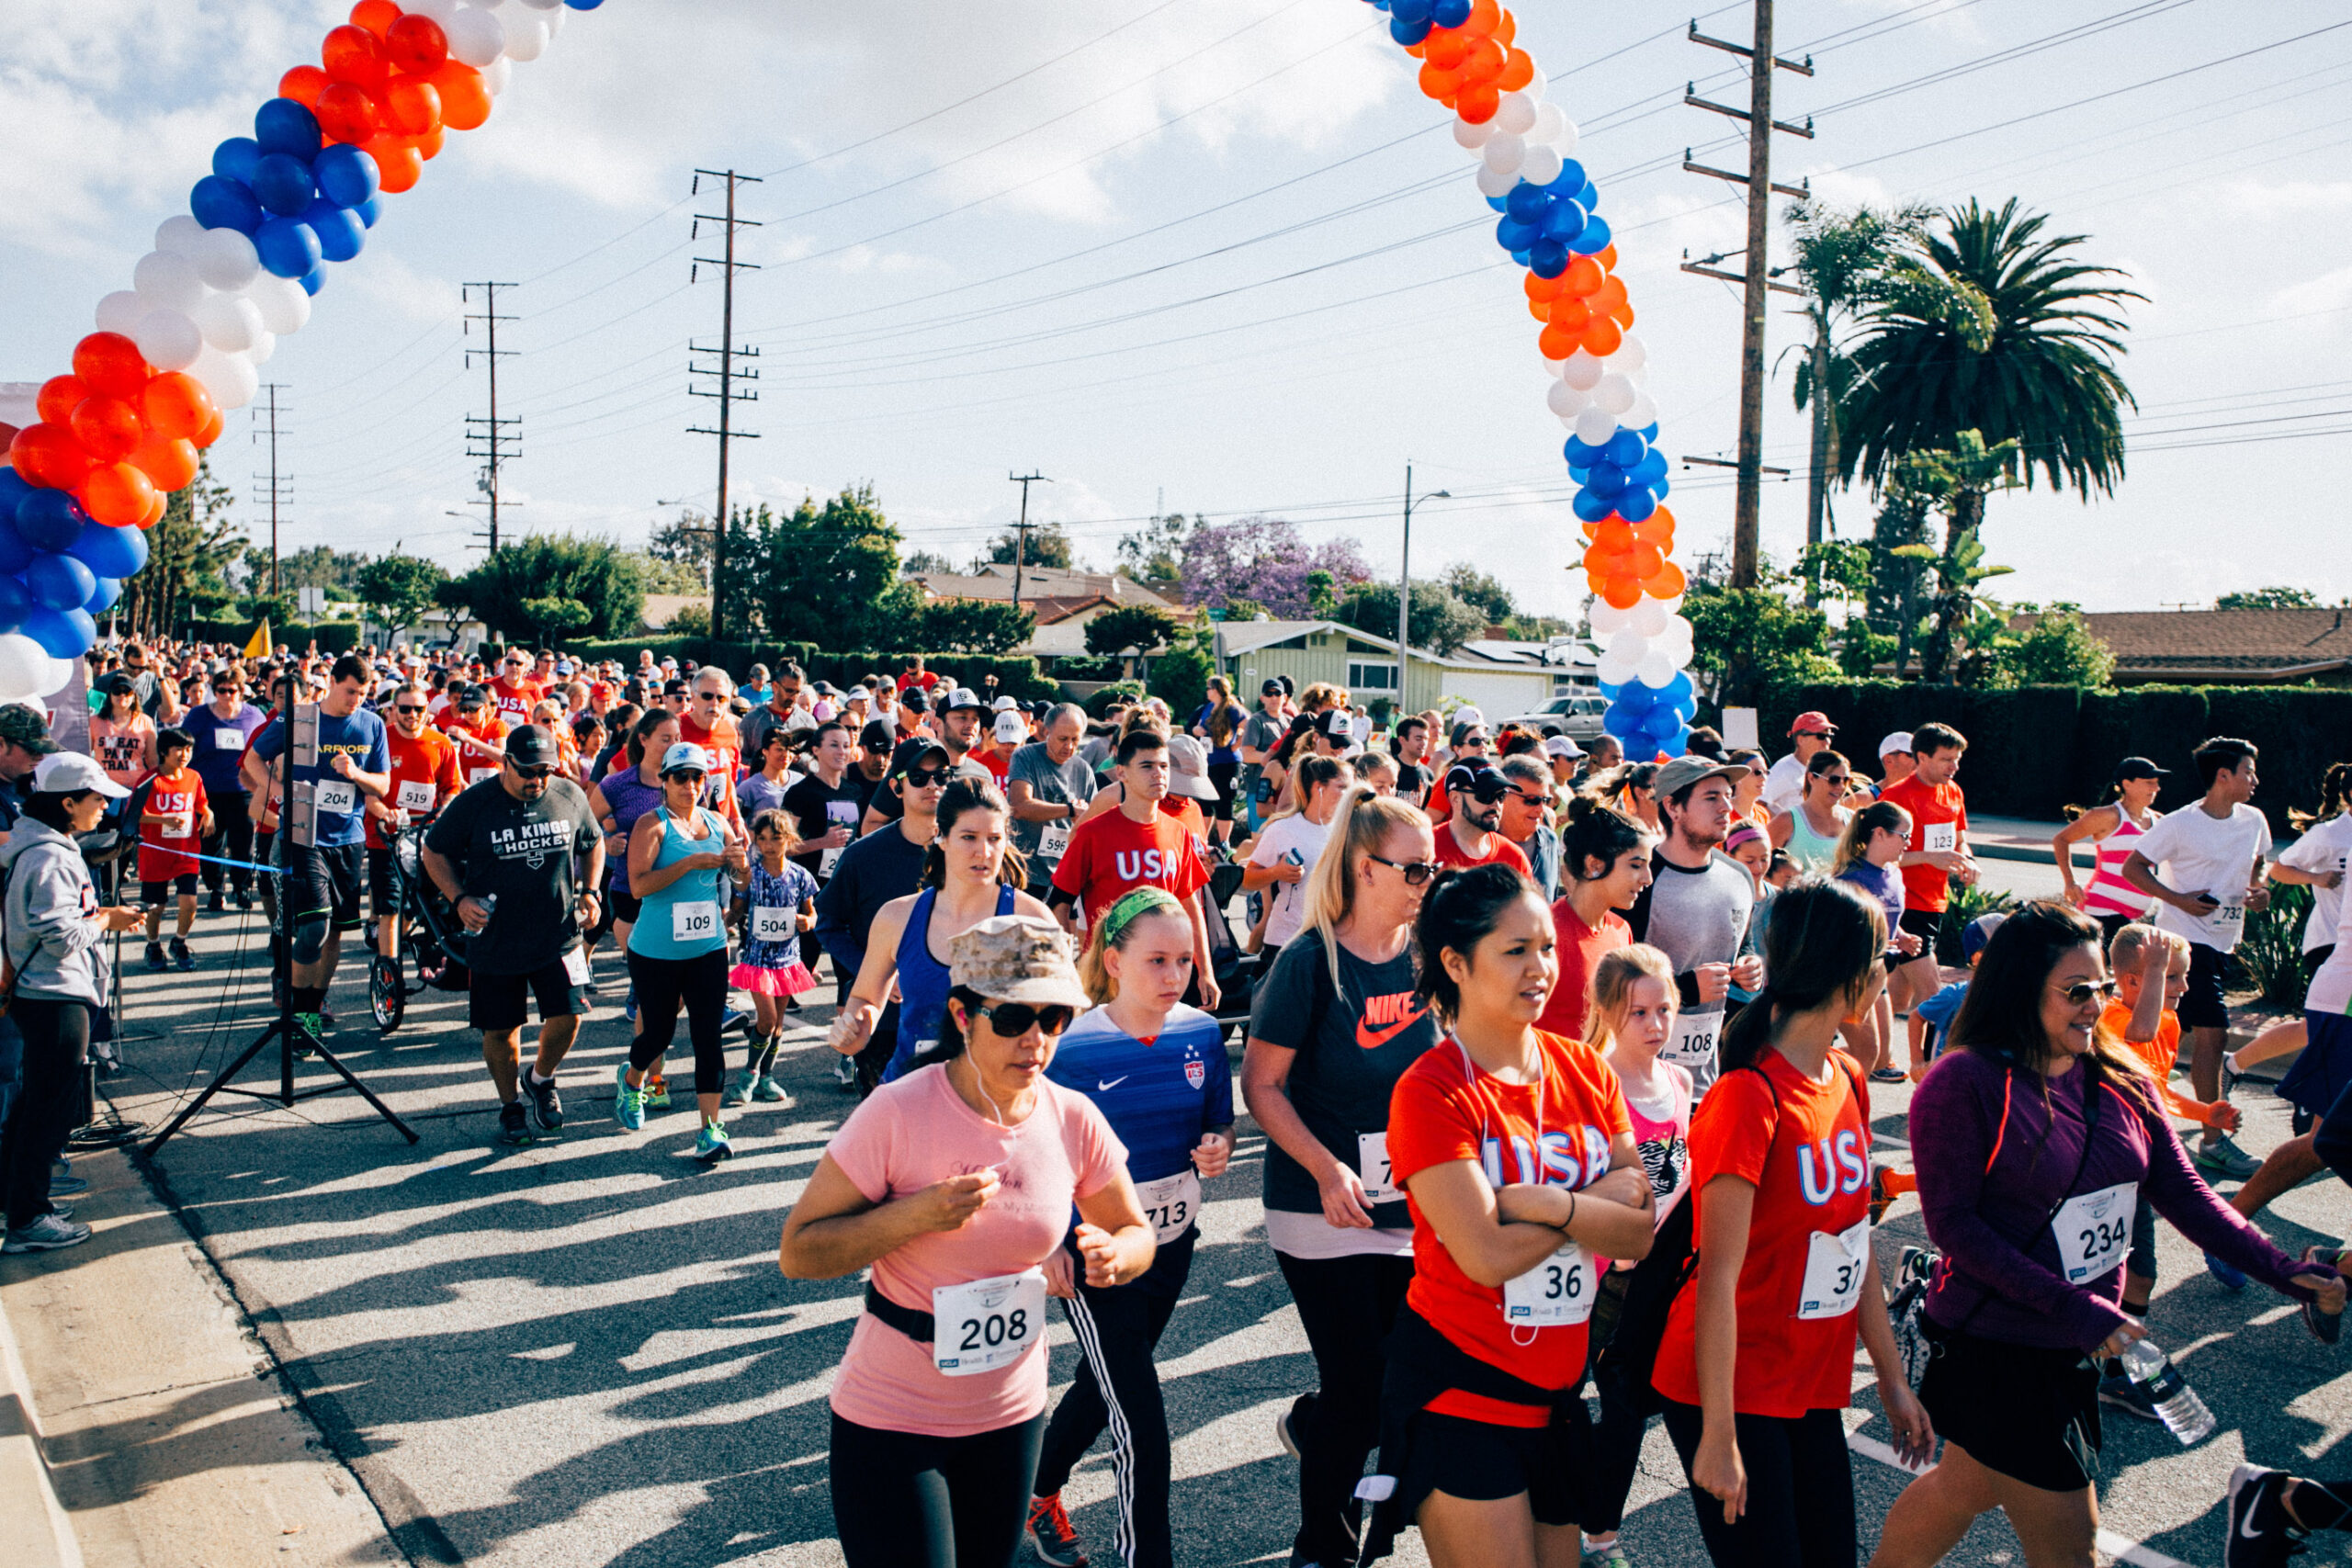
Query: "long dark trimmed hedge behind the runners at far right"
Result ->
[[1740, 680, 2352, 832]]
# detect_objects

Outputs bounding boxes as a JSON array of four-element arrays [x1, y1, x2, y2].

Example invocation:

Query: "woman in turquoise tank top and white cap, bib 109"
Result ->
[[614, 740, 751, 1164]]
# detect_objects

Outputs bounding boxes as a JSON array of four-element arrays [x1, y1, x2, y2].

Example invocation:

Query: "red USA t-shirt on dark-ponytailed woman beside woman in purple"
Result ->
[[1651, 1048, 1870, 1420]]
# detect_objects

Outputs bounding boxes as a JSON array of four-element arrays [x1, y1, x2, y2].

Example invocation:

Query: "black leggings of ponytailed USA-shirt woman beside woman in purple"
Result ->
[[1665, 1399, 1858, 1568]]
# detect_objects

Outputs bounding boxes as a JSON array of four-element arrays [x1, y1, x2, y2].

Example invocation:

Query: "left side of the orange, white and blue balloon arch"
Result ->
[[0, 0, 605, 703]]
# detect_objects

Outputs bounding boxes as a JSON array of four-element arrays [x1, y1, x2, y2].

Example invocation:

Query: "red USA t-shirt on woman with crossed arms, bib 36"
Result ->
[[1387, 1032, 1633, 1427]]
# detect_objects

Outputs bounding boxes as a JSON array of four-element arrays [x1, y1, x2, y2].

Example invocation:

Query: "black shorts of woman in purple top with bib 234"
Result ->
[[1919, 1328, 2098, 1493]]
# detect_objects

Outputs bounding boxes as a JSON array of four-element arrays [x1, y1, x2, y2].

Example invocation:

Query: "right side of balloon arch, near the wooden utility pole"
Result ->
[[1371, 0, 1698, 757]]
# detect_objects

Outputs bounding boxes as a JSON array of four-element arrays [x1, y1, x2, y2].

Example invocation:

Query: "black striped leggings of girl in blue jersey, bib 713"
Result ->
[[1035, 1229, 1197, 1568]]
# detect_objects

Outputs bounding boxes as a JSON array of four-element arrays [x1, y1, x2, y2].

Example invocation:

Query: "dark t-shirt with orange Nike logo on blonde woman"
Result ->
[[1249, 926, 1437, 1229]]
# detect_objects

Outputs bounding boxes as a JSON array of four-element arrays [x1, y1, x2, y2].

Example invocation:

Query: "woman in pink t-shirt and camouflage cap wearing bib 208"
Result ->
[[778, 915, 1155, 1568]]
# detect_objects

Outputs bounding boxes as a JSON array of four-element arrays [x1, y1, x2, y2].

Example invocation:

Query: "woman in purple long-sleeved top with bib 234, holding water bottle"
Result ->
[[1871, 903, 2345, 1568]]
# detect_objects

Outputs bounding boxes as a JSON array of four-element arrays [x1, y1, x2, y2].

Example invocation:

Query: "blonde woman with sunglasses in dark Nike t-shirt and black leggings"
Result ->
[[1242, 785, 1437, 1563]]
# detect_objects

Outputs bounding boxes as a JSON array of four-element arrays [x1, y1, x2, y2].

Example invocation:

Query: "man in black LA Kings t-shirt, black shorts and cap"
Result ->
[[424, 724, 605, 1143]]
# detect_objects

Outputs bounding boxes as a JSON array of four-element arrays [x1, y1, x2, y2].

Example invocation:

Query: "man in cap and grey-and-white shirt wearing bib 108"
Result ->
[[1625, 757, 1764, 1093]]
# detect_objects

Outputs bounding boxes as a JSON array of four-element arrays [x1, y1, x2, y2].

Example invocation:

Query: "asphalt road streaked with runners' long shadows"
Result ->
[[78, 893, 2352, 1568]]
